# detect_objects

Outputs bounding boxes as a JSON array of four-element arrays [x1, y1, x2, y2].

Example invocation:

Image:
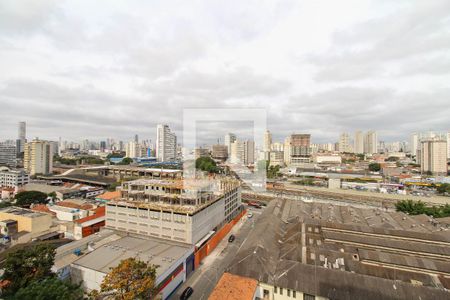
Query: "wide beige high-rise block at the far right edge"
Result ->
[[420, 138, 448, 175]]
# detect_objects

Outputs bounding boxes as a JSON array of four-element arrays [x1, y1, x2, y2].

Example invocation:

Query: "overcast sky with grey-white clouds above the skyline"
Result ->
[[0, 0, 450, 142]]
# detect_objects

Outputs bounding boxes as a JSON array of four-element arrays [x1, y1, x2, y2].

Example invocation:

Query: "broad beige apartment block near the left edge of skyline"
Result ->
[[23, 139, 53, 175]]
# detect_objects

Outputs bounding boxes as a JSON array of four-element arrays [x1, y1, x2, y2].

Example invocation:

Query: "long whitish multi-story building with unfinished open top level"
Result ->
[[106, 178, 241, 244]]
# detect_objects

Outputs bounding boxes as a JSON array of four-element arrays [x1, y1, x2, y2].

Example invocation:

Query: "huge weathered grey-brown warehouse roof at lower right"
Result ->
[[229, 199, 450, 300]]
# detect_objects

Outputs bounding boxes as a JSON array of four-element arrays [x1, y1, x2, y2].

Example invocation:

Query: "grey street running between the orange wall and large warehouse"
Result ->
[[169, 208, 264, 300]]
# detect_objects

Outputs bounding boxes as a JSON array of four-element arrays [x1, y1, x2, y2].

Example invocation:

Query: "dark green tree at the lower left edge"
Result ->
[[2, 244, 55, 294]]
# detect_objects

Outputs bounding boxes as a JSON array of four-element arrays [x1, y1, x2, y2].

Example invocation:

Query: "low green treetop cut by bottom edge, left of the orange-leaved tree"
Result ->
[[14, 277, 83, 300]]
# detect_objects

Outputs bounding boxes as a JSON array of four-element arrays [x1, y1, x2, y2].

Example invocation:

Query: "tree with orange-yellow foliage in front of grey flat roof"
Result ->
[[101, 257, 158, 300]]
